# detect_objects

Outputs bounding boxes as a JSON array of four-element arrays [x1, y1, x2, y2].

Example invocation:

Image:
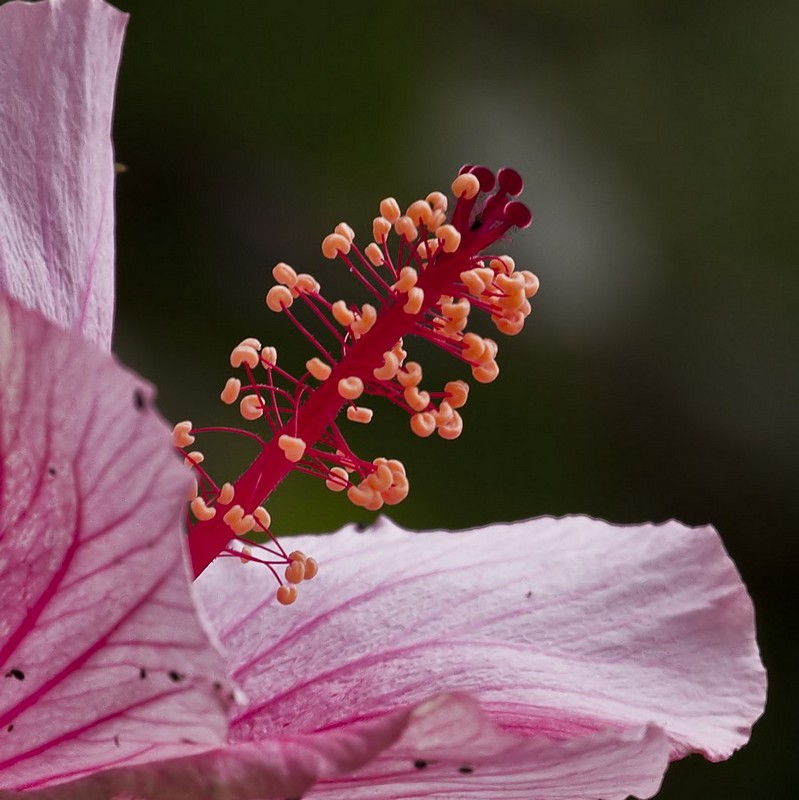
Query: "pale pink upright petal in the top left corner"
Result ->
[[0, 0, 126, 349]]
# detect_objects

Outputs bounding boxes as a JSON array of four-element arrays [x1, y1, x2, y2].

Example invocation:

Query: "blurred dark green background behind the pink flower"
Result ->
[[108, 0, 799, 800]]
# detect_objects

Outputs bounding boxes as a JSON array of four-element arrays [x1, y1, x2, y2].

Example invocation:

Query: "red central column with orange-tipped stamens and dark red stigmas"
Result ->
[[173, 165, 538, 592]]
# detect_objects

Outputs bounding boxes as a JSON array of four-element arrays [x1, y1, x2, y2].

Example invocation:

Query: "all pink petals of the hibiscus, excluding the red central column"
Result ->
[[0, 0, 765, 800]]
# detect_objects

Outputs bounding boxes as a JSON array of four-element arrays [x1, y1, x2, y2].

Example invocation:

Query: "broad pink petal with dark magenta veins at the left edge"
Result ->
[[0, 295, 230, 789]]
